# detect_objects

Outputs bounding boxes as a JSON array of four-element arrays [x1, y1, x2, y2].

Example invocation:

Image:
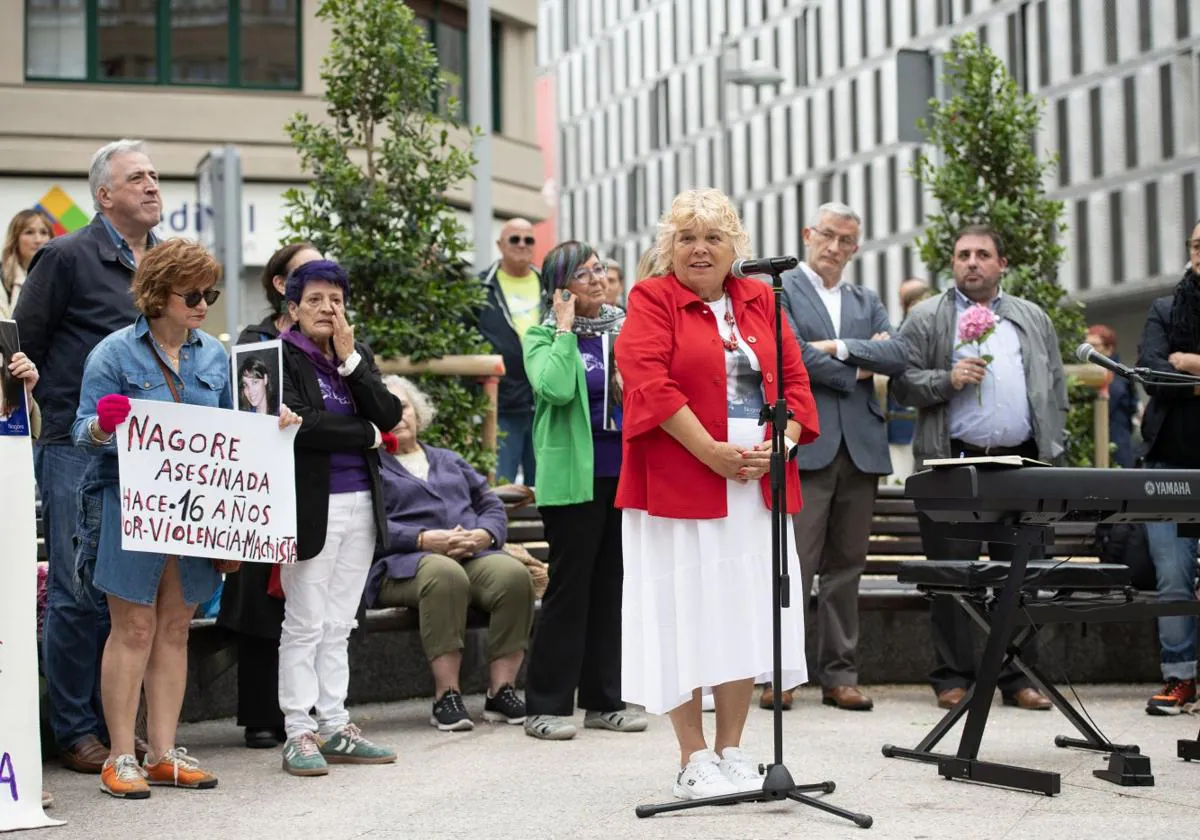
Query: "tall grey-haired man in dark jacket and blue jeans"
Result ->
[[13, 140, 162, 773]]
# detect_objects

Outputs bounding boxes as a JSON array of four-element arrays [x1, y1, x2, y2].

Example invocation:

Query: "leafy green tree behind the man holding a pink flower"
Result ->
[[913, 32, 1096, 466]]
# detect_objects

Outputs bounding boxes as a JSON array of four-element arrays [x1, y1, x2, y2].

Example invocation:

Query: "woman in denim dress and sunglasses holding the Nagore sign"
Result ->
[[72, 239, 299, 799]]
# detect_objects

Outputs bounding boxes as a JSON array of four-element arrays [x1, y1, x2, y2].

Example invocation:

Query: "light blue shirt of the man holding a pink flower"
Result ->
[[949, 289, 1033, 448]]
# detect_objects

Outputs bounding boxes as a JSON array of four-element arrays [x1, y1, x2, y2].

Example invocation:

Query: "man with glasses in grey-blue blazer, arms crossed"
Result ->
[[760, 203, 906, 712]]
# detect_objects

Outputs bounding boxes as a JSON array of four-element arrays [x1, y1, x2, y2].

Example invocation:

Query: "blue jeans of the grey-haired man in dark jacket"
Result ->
[[34, 444, 109, 750]]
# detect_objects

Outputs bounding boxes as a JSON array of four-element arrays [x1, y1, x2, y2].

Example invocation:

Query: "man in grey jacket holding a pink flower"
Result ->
[[890, 224, 1068, 709]]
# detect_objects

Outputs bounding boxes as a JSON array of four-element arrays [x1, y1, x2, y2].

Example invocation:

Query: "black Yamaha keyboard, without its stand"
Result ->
[[905, 463, 1200, 524]]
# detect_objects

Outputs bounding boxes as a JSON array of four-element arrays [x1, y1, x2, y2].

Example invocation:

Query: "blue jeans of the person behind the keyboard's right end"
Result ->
[[1146, 463, 1196, 679]]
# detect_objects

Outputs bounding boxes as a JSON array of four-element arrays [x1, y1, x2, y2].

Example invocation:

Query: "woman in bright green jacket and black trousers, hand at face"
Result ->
[[524, 241, 646, 740]]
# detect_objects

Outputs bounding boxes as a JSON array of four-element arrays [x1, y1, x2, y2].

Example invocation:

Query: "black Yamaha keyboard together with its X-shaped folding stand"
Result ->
[[883, 461, 1200, 796]]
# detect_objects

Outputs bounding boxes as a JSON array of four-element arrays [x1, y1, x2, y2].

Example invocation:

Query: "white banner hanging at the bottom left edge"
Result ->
[[0, 437, 62, 832]]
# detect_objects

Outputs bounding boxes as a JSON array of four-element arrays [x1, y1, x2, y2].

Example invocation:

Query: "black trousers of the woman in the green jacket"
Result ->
[[526, 478, 625, 716]]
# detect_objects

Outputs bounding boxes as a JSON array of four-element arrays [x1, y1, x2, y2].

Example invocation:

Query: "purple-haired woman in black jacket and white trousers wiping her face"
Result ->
[[280, 259, 401, 776]]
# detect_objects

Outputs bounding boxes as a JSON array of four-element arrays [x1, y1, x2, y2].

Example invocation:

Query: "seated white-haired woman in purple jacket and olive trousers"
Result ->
[[366, 377, 534, 732]]
